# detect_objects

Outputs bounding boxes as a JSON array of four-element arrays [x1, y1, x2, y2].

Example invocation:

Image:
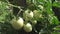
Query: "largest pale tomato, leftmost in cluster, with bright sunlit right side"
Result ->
[[11, 18, 24, 30]]
